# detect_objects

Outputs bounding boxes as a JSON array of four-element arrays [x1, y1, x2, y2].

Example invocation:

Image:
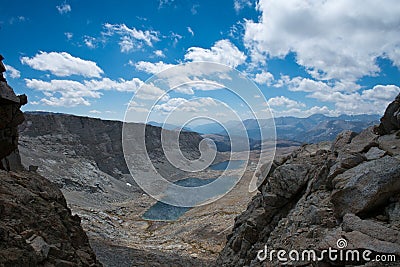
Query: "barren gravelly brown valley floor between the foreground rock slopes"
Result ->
[[20, 130, 295, 266]]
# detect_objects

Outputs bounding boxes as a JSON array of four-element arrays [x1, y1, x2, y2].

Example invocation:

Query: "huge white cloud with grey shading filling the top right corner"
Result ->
[[244, 0, 400, 81]]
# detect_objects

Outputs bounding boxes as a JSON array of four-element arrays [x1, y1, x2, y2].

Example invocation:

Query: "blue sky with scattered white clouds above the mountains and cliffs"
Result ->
[[0, 0, 400, 123]]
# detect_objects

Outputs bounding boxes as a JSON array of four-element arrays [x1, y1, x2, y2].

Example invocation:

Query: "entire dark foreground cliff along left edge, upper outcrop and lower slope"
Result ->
[[0, 56, 101, 266]]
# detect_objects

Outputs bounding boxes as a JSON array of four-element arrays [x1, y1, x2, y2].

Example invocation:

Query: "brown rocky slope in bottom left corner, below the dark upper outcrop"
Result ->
[[0, 171, 101, 266]]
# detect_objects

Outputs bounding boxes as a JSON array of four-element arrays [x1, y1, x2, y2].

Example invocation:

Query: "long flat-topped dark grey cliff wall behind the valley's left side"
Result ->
[[19, 112, 202, 187]]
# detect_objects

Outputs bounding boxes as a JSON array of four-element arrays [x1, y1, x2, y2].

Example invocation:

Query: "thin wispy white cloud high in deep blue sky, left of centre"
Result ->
[[103, 23, 160, 52]]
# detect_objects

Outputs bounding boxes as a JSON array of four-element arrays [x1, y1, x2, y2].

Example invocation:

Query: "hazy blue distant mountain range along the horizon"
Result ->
[[157, 114, 380, 151]]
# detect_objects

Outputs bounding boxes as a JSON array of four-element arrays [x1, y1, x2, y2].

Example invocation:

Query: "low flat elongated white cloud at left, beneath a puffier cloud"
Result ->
[[25, 78, 143, 107]]
